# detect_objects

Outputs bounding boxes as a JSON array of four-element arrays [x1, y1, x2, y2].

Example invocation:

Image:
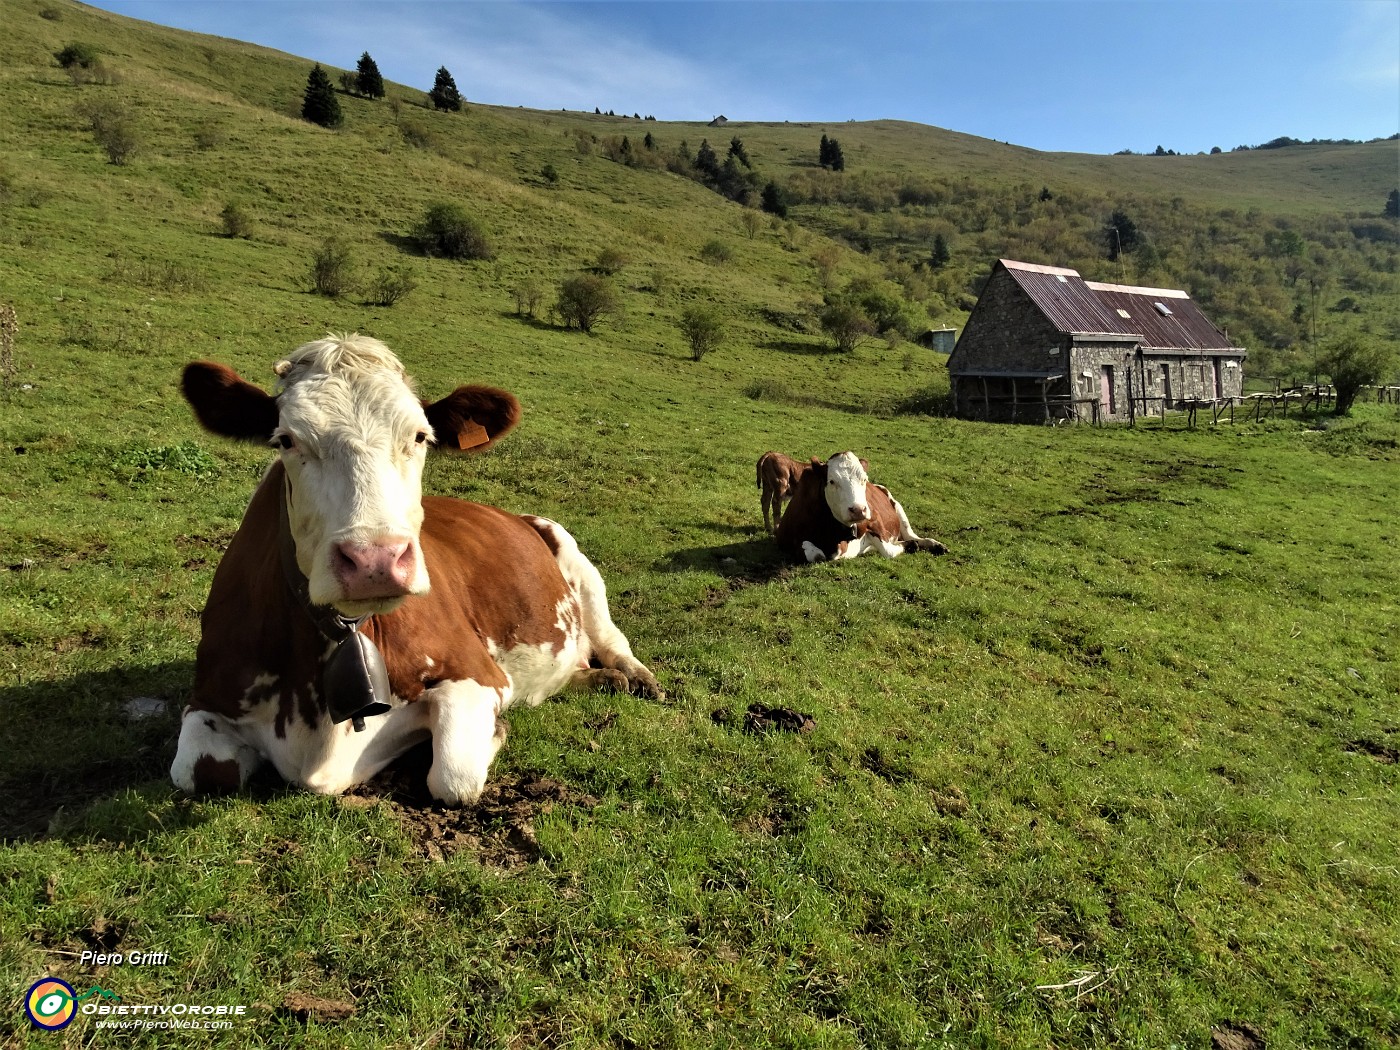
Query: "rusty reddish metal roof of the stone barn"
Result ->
[[1000, 259, 1239, 353]]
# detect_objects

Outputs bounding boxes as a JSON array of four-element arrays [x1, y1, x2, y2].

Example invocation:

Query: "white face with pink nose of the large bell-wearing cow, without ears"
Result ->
[[272, 337, 433, 616]]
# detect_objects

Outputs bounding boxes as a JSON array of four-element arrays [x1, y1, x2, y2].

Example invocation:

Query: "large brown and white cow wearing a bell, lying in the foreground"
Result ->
[[171, 336, 662, 805]]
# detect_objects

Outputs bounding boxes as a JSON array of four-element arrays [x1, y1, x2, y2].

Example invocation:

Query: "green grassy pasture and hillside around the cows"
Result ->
[[0, 0, 1400, 1050]]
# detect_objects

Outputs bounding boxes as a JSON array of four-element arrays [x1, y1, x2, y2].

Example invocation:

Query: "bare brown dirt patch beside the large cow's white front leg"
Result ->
[[342, 748, 598, 871]]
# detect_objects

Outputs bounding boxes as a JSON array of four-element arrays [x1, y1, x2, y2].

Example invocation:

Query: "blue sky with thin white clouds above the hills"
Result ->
[[88, 0, 1400, 153]]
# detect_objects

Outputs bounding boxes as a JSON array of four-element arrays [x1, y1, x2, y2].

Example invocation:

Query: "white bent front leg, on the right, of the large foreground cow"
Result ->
[[431, 682, 507, 806]]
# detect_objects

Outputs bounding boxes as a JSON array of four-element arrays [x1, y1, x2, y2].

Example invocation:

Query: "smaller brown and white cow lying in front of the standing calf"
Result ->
[[777, 452, 948, 561]]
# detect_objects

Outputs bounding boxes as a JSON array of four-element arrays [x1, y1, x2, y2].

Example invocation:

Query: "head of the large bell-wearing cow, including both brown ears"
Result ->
[[183, 336, 519, 616]]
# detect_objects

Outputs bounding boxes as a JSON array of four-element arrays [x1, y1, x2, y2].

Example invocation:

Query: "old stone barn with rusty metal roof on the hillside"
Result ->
[[948, 259, 1245, 423]]
